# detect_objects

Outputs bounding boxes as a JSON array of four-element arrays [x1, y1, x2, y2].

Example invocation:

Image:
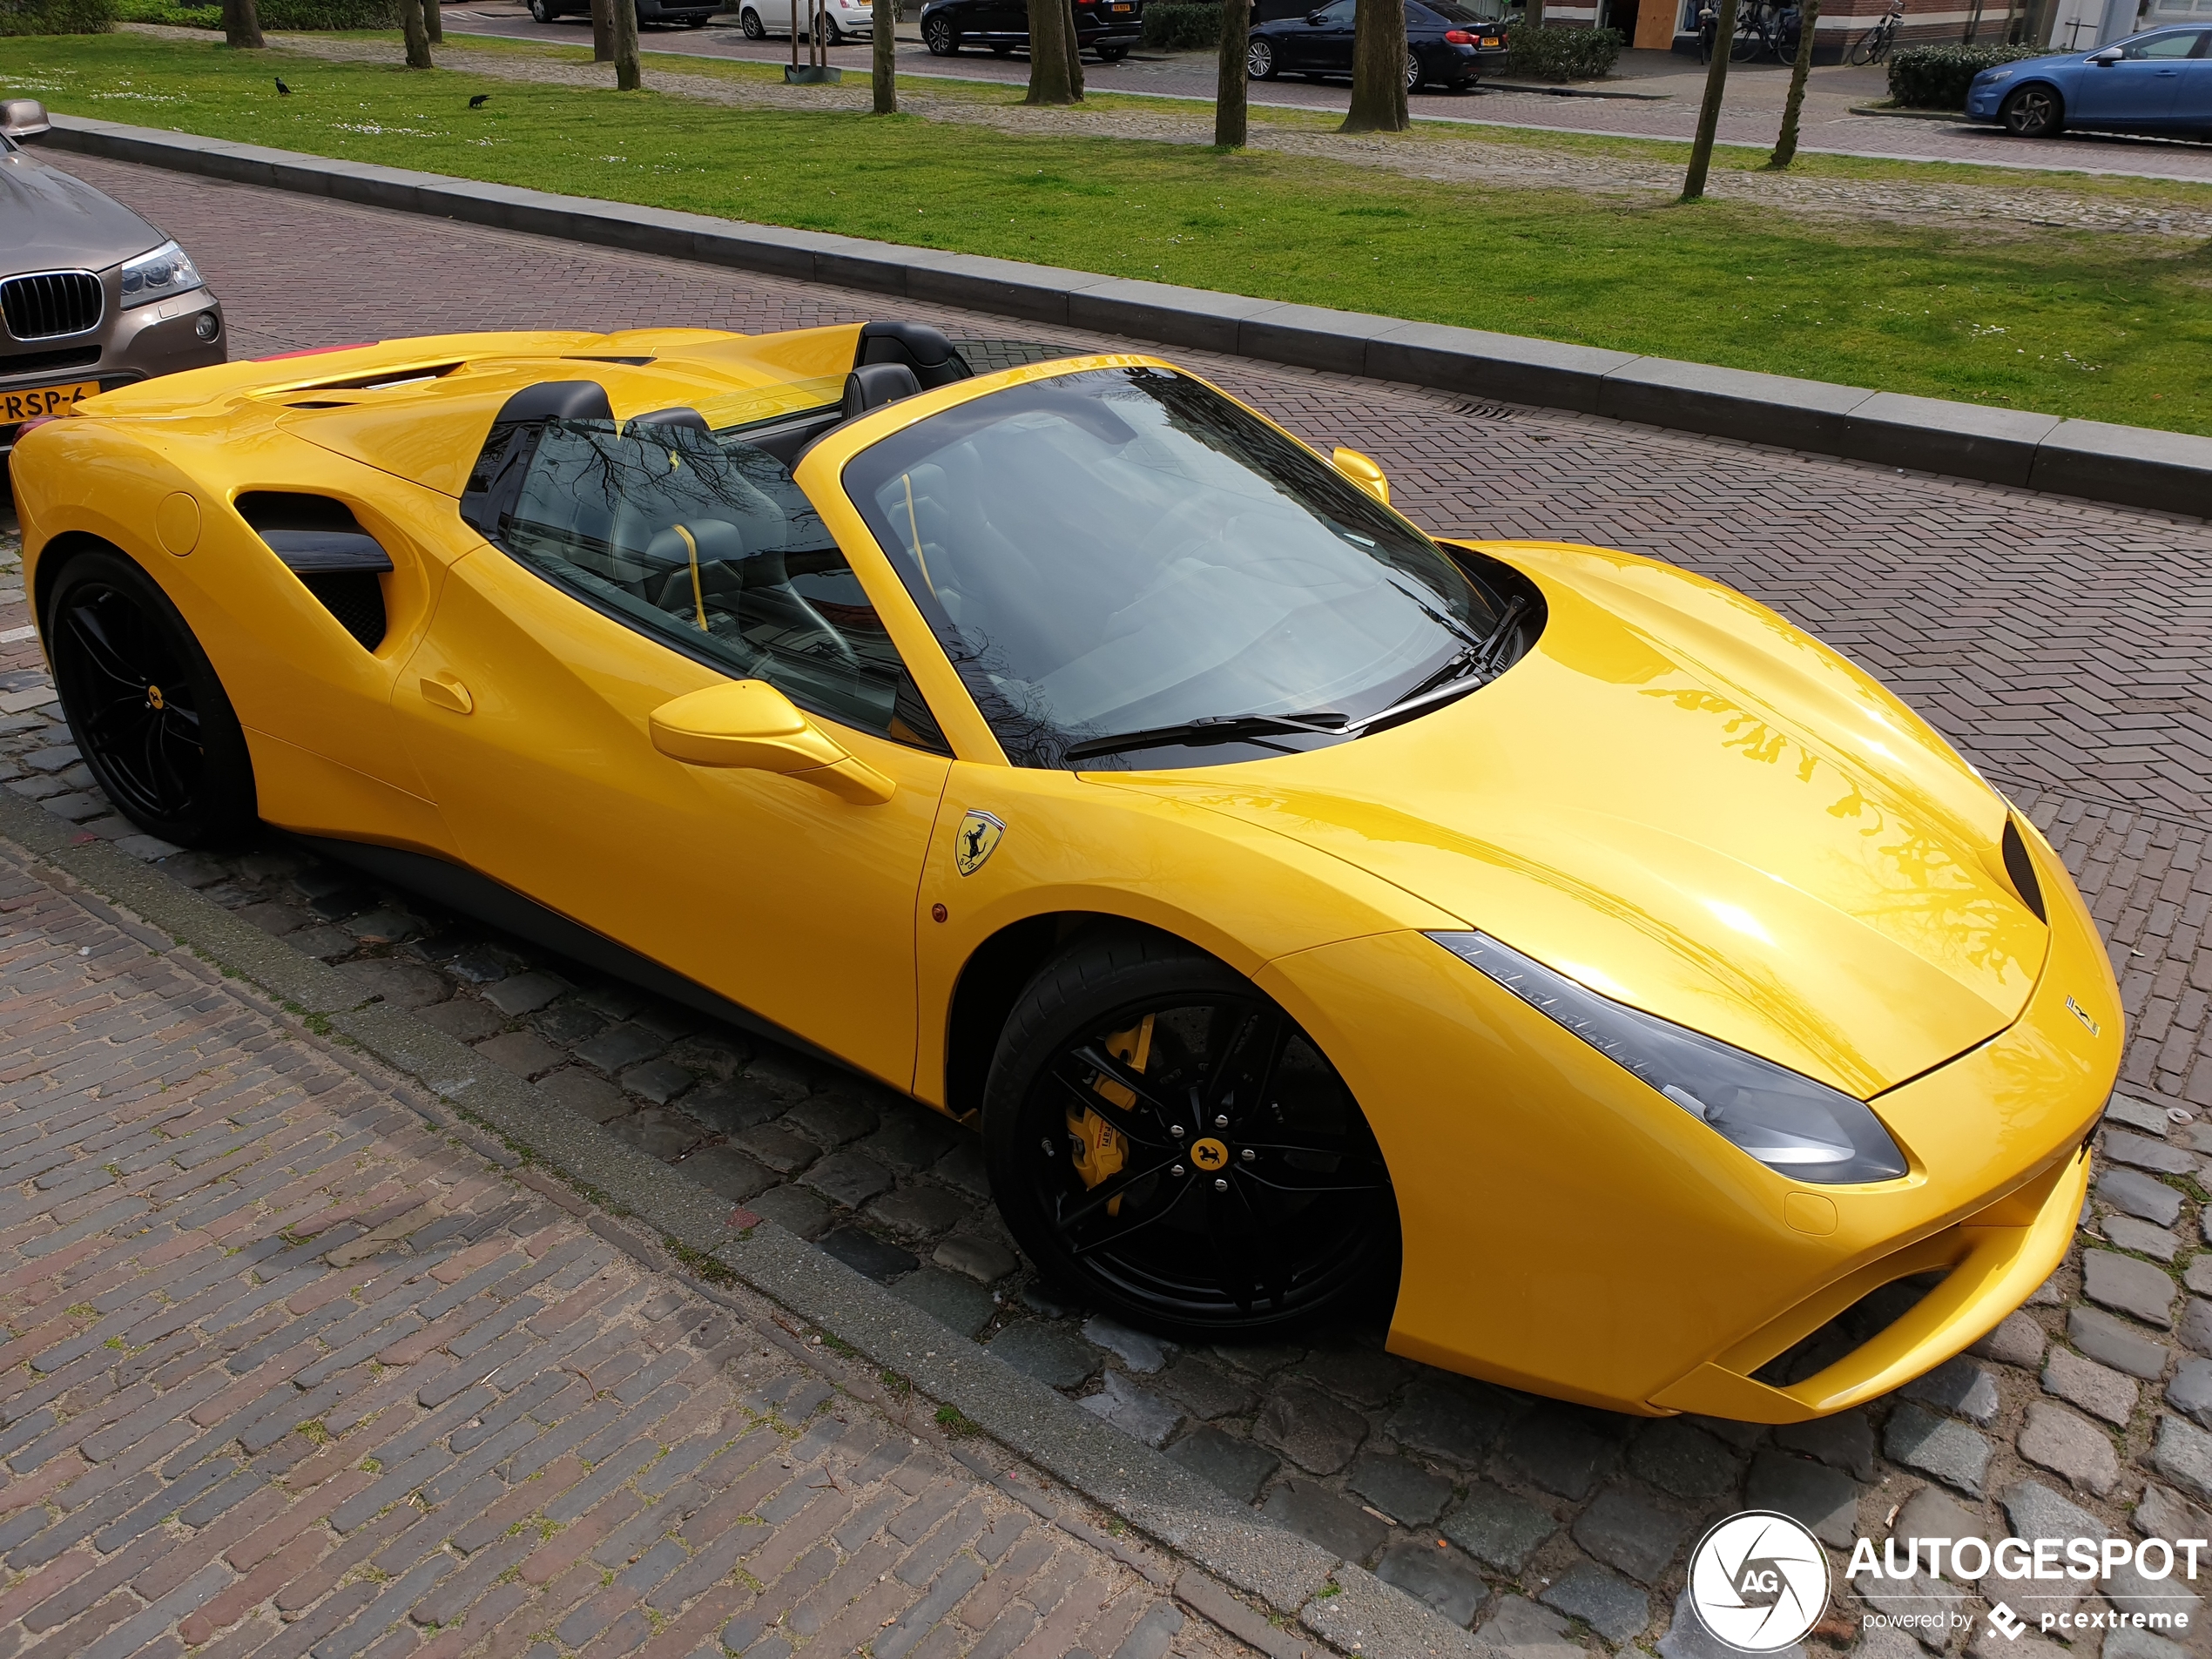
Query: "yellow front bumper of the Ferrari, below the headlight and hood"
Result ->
[[1258, 813, 2121, 1422]]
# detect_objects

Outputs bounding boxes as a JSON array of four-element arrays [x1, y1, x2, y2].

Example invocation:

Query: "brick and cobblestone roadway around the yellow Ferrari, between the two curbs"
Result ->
[[12, 159, 2212, 1659]]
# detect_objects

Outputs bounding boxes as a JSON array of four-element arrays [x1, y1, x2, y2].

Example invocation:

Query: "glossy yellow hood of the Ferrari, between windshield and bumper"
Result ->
[[1102, 542, 2055, 1099]]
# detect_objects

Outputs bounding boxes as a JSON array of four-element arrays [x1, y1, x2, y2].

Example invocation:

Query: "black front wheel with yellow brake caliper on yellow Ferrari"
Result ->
[[984, 931, 1398, 1340]]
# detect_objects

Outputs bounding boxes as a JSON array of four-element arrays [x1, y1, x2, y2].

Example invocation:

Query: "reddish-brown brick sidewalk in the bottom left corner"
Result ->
[[0, 845, 1250, 1659]]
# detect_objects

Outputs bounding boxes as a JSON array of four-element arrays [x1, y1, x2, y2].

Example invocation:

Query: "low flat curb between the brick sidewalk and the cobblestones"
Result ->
[[0, 792, 1478, 1655]]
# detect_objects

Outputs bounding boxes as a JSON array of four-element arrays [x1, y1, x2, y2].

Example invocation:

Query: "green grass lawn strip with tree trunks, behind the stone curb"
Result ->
[[12, 36, 2212, 434]]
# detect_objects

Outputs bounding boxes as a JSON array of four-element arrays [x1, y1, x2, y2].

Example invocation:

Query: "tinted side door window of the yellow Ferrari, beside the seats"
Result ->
[[498, 421, 942, 750]]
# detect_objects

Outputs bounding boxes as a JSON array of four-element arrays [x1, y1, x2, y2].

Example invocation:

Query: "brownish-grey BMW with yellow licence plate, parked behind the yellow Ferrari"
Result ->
[[0, 98, 230, 454]]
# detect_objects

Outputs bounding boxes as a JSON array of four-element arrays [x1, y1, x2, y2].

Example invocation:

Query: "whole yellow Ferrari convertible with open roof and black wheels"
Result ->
[[16, 323, 2121, 1420]]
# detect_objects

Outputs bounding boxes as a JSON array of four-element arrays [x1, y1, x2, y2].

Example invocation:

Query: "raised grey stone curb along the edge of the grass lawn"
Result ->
[[34, 115, 2212, 517]]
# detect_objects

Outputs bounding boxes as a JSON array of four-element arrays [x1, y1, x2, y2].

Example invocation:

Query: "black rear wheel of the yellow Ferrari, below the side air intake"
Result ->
[[46, 550, 254, 847]]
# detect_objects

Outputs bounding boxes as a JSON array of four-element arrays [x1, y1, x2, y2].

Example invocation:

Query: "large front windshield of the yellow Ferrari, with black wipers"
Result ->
[[845, 368, 1508, 767]]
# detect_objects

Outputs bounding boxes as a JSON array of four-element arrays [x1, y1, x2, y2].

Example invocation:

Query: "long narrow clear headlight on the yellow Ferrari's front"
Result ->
[[1429, 934, 1905, 1185]]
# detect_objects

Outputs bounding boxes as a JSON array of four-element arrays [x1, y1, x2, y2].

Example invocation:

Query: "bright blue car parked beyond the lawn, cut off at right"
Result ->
[[1966, 26, 2212, 137]]
